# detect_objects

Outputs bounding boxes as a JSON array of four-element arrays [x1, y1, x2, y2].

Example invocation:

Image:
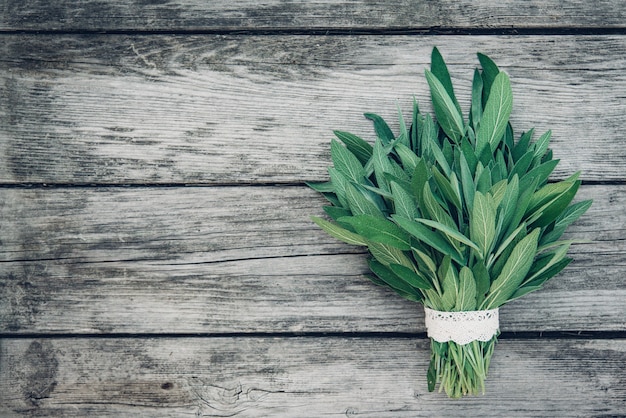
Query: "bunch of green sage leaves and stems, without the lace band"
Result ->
[[310, 48, 591, 397]]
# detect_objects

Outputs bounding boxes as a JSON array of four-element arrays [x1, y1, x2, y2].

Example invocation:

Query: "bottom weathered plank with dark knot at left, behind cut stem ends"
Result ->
[[0, 338, 626, 417]]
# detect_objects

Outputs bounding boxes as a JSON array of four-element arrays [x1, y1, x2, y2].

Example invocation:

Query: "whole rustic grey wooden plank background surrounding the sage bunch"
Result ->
[[0, 0, 626, 417]]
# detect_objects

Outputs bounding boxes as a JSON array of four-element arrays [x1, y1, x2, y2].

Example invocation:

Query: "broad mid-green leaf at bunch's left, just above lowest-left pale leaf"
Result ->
[[338, 215, 411, 250]]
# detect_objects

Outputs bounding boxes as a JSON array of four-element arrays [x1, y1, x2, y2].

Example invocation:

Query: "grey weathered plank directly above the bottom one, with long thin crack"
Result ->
[[0, 186, 626, 333]]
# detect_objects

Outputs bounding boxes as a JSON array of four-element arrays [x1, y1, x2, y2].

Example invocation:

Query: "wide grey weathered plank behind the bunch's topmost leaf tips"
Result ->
[[0, 35, 626, 184]]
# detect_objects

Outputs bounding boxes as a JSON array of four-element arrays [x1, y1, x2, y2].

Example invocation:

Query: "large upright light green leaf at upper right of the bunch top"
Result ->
[[476, 72, 513, 155]]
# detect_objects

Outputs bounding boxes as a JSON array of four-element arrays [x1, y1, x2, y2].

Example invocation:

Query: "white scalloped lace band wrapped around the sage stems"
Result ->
[[424, 306, 500, 345]]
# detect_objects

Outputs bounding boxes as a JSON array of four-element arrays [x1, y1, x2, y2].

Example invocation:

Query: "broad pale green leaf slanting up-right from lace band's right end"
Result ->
[[483, 228, 540, 309]]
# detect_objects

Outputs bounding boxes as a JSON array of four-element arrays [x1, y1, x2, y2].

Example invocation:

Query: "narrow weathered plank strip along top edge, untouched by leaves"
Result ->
[[0, 0, 626, 30]]
